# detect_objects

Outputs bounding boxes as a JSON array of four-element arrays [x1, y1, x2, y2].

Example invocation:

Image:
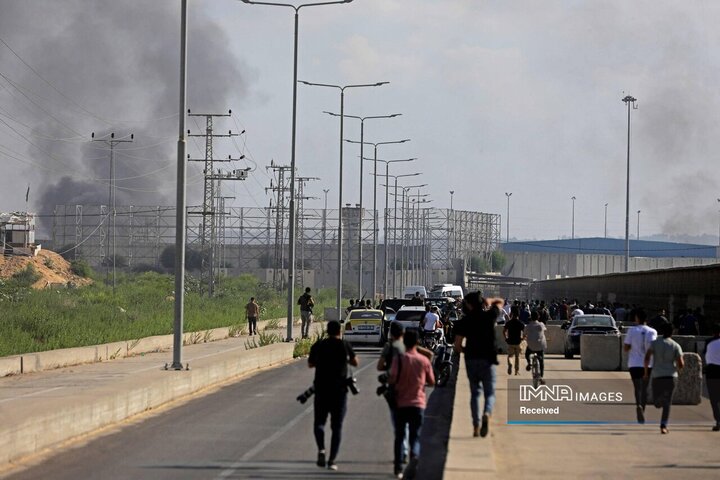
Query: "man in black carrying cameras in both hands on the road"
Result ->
[[308, 320, 358, 470]]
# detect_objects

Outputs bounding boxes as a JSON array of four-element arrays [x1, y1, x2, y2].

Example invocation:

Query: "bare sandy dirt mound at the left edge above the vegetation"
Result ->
[[0, 250, 92, 289]]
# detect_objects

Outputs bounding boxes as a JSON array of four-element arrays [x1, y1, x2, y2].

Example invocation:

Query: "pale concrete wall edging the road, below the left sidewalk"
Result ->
[[0, 343, 294, 464]]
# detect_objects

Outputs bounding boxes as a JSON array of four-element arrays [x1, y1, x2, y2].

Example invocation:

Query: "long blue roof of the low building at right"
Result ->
[[501, 237, 718, 258]]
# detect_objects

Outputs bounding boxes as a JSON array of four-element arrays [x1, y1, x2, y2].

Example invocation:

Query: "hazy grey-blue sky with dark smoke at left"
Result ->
[[0, 0, 720, 239]]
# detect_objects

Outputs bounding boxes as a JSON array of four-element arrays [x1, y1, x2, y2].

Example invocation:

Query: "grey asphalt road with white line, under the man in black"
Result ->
[[9, 351, 408, 480]]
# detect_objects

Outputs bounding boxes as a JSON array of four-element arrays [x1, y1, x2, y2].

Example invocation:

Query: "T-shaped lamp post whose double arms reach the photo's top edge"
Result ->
[[241, 0, 353, 342]]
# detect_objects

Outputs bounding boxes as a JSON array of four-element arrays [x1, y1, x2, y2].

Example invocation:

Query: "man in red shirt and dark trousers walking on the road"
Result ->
[[389, 329, 435, 478]]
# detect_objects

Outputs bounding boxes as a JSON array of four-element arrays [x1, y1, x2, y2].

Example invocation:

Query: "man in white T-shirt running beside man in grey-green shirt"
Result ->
[[623, 308, 657, 423]]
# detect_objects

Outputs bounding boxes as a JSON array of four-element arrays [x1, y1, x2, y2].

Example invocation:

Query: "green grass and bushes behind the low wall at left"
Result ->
[[0, 272, 334, 356]]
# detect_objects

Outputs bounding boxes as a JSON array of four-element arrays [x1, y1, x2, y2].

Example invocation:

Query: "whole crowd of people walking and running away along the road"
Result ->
[[246, 288, 720, 478]]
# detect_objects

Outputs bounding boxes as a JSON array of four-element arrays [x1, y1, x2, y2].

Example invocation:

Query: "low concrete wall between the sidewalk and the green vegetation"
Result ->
[[0, 319, 284, 377]]
